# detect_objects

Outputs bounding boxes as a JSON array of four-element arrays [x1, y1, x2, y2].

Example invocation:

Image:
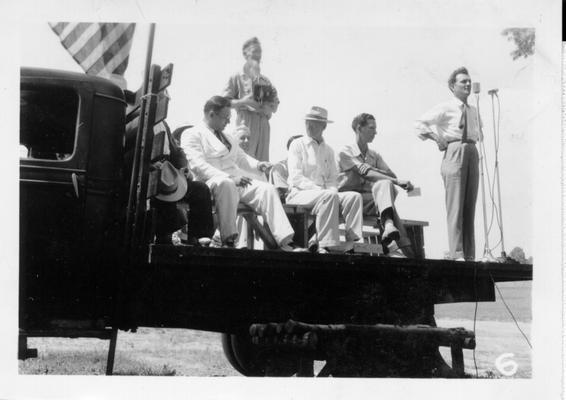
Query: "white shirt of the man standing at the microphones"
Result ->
[[415, 97, 481, 142]]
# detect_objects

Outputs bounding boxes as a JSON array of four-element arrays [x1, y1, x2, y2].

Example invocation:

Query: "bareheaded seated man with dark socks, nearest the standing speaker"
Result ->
[[338, 113, 413, 256]]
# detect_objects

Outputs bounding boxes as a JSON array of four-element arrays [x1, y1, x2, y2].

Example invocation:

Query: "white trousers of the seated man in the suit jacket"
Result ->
[[206, 177, 295, 245]]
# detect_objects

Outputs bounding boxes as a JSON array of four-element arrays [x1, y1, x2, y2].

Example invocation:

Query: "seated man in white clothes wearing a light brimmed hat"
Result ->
[[287, 107, 363, 253]]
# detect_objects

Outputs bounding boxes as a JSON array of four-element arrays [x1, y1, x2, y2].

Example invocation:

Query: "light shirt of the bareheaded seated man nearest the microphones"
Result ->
[[338, 142, 392, 192]]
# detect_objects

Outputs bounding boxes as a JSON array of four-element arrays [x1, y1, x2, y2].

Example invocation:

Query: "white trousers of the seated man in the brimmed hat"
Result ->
[[286, 189, 363, 247]]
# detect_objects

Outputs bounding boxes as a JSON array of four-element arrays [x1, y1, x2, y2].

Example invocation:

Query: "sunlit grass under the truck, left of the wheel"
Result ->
[[19, 328, 239, 376]]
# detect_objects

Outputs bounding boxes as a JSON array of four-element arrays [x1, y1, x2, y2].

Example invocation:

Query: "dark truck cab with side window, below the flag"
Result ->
[[20, 68, 126, 329]]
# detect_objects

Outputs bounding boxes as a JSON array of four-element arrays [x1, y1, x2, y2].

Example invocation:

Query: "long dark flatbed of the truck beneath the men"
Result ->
[[128, 245, 532, 332]]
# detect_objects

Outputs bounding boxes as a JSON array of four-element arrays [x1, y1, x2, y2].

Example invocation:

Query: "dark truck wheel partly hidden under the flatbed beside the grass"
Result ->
[[222, 333, 299, 376]]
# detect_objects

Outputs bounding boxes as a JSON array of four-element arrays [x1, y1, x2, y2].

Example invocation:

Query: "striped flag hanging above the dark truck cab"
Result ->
[[49, 22, 136, 87]]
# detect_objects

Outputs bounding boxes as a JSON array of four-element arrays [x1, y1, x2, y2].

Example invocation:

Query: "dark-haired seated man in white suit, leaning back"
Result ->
[[181, 96, 300, 251]]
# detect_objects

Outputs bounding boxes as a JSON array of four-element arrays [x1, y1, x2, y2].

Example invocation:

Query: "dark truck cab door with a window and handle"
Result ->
[[20, 77, 88, 327]]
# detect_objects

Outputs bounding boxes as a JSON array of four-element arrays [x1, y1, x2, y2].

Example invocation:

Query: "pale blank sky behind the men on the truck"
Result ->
[[20, 20, 536, 258]]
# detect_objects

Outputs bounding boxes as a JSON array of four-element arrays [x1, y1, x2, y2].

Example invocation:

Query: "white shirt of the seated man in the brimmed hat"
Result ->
[[287, 136, 338, 191]]
